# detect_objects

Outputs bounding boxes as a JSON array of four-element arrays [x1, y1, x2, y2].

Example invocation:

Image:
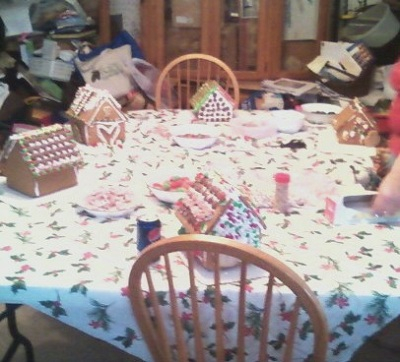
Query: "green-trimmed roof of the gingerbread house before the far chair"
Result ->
[[190, 80, 235, 112]]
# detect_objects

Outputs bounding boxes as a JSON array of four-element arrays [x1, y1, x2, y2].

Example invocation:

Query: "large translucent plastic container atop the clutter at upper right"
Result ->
[[342, 3, 400, 48]]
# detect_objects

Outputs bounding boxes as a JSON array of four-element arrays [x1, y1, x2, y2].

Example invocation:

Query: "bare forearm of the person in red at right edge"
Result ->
[[372, 156, 400, 215]]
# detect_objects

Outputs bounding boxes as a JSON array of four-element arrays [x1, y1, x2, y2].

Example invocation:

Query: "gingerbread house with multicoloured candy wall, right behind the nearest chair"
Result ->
[[175, 173, 266, 268]]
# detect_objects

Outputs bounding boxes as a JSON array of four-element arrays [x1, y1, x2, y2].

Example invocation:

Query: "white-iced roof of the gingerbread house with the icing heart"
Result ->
[[67, 84, 126, 123]]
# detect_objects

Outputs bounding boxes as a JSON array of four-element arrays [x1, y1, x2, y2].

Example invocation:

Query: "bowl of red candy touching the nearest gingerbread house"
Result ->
[[147, 169, 193, 204]]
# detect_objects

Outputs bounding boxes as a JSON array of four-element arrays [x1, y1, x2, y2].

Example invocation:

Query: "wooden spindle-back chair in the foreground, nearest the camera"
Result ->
[[129, 234, 328, 362]]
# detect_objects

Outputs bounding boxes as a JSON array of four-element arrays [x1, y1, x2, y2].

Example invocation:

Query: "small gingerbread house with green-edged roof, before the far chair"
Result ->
[[190, 80, 235, 122]]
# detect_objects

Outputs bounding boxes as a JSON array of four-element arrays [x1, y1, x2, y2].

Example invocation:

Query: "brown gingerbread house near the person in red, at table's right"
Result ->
[[332, 98, 380, 147]]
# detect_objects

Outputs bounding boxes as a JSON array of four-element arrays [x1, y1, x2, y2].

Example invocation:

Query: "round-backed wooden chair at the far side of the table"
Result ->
[[155, 53, 239, 109]]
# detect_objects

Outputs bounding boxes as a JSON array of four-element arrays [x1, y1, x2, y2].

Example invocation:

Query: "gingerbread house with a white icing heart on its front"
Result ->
[[67, 84, 127, 146]]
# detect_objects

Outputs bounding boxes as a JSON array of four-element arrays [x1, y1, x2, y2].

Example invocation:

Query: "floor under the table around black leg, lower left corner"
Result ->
[[0, 305, 141, 362]]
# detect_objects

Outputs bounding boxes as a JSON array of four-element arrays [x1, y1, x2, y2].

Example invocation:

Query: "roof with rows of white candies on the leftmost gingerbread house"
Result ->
[[1, 124, 82, 177]]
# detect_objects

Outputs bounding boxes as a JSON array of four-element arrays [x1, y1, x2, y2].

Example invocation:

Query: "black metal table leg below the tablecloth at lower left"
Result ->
[[0, 304, 35, 362]]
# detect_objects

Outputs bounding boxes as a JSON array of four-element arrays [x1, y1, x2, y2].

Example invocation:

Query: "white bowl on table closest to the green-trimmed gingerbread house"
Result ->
[[170, 123, 220, 150]]
